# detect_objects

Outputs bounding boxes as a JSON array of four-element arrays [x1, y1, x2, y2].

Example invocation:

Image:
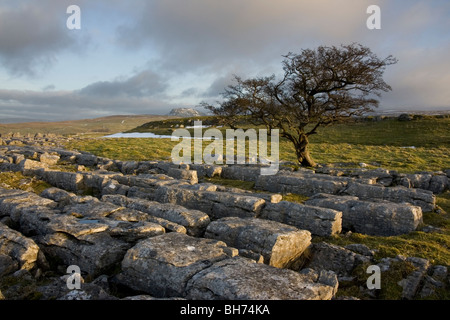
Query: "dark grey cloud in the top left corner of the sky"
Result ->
[[0, 0, 86, 76]]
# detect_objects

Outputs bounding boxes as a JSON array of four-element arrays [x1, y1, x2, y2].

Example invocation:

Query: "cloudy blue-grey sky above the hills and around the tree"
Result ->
[[0, 0, 450, 122]]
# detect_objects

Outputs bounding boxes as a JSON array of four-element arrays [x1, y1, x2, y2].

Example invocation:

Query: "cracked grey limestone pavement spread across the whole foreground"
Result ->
[[0, 139, 449, 300]]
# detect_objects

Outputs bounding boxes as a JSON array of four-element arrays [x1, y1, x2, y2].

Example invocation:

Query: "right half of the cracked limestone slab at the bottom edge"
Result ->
[[186, 257, 335, 300]]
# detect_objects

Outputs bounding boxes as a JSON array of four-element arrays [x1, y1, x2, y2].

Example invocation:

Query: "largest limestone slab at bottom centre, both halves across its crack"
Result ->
[[119, 233, 335, 300]]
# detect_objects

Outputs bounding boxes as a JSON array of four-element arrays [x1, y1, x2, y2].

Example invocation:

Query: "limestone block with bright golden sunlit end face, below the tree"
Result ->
[[205, 217, 311, 268]]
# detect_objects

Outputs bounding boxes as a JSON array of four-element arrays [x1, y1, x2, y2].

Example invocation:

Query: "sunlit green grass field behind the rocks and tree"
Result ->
[[68, 117, 450, 173]]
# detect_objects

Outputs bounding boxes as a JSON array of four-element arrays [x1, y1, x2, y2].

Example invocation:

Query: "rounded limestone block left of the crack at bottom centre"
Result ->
[[118, 233, 237, 298]]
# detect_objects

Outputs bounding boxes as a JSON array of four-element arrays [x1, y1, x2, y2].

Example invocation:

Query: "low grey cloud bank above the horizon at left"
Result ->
[[0, 71, 173, 122]]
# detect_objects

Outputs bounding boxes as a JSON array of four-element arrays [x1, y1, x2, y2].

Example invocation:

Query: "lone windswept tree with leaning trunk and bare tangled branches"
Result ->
[[202, 44, 397, 167]]
